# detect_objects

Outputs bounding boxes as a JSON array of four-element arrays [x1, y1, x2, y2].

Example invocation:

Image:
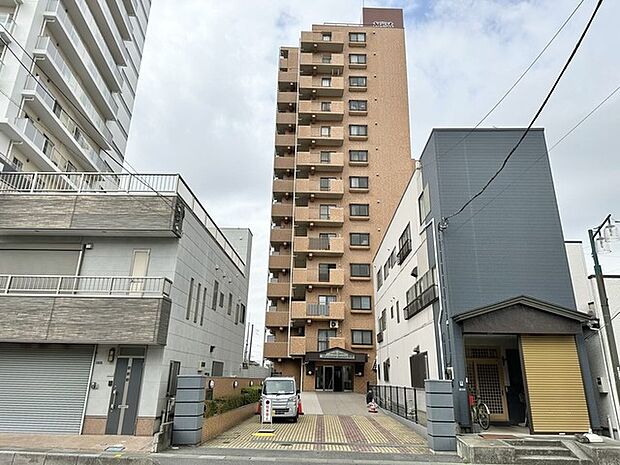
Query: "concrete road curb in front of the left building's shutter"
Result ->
[[0, 450, 157, 465]]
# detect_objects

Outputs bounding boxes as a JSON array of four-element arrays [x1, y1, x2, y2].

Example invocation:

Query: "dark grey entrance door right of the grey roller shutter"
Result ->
[[105, 348, 144, 436]]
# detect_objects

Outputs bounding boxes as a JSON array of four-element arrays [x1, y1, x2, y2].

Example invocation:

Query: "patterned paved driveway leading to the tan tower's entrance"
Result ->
[[201, 393, 429, 454]]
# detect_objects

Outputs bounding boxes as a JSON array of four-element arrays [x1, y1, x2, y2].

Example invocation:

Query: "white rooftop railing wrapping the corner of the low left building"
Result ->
[[0, 172, 245, 274]]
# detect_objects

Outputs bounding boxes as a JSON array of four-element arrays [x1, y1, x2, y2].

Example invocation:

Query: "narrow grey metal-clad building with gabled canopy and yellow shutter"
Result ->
[[418, 128, 599, 432]]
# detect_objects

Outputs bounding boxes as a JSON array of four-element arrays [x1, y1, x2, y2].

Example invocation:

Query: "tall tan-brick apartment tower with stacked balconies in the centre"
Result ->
[[264, 8, 414, 392]]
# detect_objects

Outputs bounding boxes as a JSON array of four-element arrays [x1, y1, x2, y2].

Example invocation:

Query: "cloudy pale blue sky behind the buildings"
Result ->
[[126, 0, 620, 360]]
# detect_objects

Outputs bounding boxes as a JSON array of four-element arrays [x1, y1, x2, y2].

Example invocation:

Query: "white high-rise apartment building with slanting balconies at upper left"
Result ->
[[0, 0, 151, 172]]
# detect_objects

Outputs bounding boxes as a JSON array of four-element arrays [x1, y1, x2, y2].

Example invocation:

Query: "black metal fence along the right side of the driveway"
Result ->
[[369, 384, 426, 424]]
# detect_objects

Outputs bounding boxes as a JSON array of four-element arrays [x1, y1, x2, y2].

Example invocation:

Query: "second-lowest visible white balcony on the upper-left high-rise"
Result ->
[[22, 76, 112, 171]]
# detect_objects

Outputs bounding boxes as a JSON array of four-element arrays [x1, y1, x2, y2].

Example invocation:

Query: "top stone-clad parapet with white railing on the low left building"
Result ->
[[0, 173, 245, 274]]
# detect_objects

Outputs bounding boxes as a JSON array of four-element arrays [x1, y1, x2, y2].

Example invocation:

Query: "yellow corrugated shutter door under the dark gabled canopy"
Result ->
[[521, 336, 590, 433]]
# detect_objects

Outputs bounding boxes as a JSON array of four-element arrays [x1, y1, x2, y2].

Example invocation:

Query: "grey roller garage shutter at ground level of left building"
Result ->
[[0, 344, 94, 434]]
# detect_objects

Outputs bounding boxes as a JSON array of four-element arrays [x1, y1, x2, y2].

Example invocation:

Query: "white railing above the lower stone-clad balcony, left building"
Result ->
[[0, 275, 172, 297]]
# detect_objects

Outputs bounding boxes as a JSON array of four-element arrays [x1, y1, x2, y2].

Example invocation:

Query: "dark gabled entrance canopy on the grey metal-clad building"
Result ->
[[454, 296, 590, 334]]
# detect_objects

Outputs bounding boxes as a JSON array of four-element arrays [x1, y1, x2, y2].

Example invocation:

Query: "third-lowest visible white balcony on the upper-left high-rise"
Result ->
[[32, 36, 115, 144]]
